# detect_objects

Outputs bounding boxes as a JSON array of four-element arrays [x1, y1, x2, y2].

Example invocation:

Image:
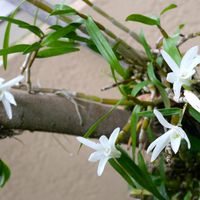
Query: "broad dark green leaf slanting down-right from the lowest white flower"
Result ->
[[116, 146, 165, 200]]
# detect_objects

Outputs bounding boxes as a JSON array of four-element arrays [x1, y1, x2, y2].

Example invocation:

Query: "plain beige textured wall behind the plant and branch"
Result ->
[[0, 0, 200, 200]]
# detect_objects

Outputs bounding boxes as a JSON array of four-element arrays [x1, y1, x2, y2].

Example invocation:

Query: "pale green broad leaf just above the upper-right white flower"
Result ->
[[163, 36, 181, 65]]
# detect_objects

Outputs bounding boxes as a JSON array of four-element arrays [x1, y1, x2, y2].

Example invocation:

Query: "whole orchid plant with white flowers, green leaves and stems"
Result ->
[[0, 0, 200, 200]]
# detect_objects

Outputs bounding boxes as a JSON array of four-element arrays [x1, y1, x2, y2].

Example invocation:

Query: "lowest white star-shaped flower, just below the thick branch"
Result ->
[[77, 128, 121, 176]]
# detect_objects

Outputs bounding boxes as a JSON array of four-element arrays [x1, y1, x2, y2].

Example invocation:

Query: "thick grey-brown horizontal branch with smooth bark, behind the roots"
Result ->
[[0, 91, 130, 137]]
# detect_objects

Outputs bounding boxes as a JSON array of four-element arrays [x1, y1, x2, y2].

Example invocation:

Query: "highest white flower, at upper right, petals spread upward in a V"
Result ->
[[161, 46, 200, 99]]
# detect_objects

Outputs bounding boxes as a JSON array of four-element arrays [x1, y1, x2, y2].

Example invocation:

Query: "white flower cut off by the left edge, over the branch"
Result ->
[[0, 75, 24, 119]]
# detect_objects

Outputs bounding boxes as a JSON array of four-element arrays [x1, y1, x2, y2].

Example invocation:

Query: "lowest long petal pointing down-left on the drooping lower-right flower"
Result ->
[[149, 130, 172, 162]]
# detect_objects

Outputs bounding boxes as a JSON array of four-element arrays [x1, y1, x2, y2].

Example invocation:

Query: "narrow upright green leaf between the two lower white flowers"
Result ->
[[131, 105, 141, 160]]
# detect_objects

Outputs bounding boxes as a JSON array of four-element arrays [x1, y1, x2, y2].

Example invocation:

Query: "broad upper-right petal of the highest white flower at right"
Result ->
[[180, 46, 198, 71]]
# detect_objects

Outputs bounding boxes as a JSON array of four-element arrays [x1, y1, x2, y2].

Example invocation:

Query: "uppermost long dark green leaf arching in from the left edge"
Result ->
[[0, 16, 44, 38]]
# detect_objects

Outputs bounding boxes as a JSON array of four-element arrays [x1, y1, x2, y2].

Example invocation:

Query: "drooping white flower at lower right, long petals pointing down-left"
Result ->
[[147, 109, 191, 162]]
